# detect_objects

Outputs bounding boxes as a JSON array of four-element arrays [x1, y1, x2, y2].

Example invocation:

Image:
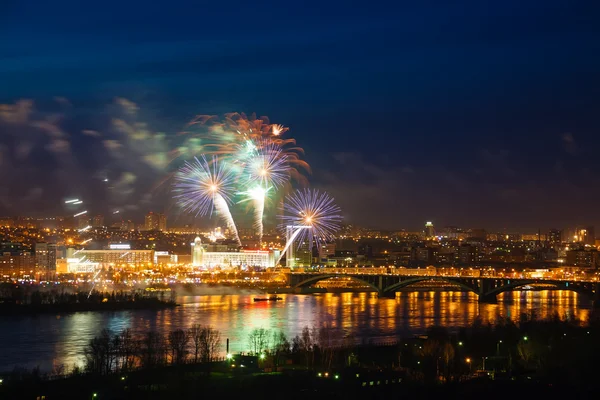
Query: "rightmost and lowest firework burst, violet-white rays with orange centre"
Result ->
[[280, 189, 342, 248]]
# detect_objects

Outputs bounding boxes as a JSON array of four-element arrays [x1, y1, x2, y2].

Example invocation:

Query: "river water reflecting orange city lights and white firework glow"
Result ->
[[0, 291, 591, 372]]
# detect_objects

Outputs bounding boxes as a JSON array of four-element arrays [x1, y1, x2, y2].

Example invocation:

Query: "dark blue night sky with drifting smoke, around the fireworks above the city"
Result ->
[[0, 0, 600, 231]]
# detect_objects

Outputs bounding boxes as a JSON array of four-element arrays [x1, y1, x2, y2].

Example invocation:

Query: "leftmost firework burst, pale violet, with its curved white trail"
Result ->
[[175, 156, 241, 244]]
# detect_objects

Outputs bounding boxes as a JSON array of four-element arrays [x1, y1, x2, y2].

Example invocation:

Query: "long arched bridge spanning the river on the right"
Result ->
[[288, 272, 600, 306]]
